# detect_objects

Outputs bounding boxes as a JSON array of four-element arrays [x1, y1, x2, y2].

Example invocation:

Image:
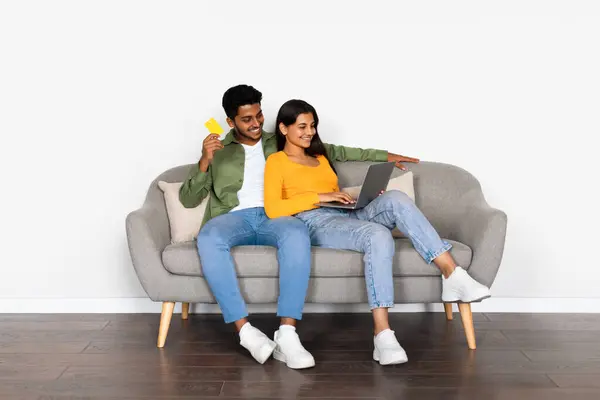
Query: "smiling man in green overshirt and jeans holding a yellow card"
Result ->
[[179, 85, 418, 369]]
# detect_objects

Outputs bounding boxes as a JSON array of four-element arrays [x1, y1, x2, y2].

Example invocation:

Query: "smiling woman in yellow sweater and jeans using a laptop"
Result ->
[[265, 100, 490, 365]]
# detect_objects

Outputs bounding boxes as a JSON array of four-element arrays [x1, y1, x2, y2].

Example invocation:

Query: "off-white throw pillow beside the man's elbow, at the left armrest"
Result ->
[[158, 181, 210, 244]]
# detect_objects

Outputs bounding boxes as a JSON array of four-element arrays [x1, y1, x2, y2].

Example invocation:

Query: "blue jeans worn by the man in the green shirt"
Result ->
[[197, 207, 311, 323]]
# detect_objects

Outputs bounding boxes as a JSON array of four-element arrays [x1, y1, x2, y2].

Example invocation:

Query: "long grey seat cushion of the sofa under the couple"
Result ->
[[163, 239, 472, 278]]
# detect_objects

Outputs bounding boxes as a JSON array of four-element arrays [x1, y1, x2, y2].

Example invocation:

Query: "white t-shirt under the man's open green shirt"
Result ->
[[231, 139, 266, 211]]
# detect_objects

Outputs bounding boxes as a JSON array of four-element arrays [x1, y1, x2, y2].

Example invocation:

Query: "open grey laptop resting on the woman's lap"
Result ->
[[317, 161, 396, 210]]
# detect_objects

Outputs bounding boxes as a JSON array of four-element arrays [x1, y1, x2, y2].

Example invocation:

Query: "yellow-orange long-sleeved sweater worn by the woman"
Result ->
[[265, 151, 340, 218]]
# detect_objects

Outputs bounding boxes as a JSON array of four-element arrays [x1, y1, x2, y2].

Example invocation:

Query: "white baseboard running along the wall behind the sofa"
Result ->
[[0, 297, 600, 314]]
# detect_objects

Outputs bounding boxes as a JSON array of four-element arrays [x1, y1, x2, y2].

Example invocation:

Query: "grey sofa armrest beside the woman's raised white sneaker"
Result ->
[[452, 201, 507, 287]]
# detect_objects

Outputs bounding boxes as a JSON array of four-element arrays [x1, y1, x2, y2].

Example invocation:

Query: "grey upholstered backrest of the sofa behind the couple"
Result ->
[[146, 161, 483, 237]]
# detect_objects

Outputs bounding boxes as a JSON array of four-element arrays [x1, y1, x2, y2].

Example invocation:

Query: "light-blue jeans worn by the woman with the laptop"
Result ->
[[296, 190, 451, 309]]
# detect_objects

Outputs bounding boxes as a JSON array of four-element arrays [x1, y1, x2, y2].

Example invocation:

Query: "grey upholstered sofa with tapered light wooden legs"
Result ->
[[126, 162, 507, 349]]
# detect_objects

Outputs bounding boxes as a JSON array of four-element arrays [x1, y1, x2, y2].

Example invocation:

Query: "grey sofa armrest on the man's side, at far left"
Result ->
[[125, 203, 171, 301]]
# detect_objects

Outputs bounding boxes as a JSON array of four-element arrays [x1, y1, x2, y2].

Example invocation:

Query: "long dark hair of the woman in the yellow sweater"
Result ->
[[275, 99, 337, 175]]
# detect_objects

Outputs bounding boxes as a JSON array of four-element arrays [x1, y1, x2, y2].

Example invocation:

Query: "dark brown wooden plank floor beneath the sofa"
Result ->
[[0, 313, 600, 400]]
